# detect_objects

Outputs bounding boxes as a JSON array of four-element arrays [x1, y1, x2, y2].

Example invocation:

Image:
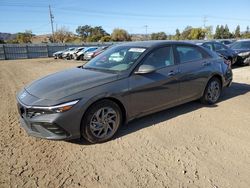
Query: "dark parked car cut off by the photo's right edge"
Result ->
[[230, 40, 250, 65]]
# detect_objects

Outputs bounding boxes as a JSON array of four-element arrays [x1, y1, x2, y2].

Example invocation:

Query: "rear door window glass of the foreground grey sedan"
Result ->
[[176, 46, 203, 63]]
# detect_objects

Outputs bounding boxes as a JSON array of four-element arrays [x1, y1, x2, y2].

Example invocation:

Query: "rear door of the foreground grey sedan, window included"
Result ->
[[176, 45, 211, 101]]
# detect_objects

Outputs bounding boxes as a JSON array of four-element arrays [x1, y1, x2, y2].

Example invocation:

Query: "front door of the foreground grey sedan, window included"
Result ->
[[129, 46, 179, 116]]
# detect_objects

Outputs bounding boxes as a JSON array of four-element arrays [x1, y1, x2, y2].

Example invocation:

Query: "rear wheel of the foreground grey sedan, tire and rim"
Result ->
[[200, 77, 222, 105]]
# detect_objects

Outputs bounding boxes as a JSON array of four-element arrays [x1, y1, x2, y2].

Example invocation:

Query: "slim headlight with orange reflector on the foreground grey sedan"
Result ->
[[27, 100, 79, 118]]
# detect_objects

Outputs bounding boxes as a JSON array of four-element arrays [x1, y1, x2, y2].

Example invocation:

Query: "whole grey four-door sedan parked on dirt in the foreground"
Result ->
[[17, 41, 232, 143]]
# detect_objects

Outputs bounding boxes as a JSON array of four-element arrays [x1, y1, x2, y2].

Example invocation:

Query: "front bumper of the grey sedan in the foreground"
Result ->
[[17, 100, 81, 140]]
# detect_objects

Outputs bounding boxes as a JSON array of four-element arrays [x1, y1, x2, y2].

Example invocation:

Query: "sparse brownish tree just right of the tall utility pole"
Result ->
[[53, 27, 74, 43]]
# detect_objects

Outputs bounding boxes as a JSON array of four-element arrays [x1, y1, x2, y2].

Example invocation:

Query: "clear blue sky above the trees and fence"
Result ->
[[0, 0, 250, 34]]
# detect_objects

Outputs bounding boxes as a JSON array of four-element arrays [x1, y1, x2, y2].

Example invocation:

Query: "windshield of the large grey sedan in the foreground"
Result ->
[[83, 46, 146, 71]]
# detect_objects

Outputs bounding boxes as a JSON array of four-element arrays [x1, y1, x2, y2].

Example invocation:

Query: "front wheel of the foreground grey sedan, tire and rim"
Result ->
[[81, 99, 123, 143]]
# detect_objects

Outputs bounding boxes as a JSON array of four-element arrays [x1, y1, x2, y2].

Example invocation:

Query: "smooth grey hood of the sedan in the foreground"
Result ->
[[25, 68, 118, 100]]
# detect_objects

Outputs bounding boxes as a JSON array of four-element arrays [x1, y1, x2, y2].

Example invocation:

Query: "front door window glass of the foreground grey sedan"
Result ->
[[143, 47, 174, 69]]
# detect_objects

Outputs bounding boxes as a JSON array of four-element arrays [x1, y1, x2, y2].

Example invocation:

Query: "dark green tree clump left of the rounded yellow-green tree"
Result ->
[[76, 25, 109, 42]]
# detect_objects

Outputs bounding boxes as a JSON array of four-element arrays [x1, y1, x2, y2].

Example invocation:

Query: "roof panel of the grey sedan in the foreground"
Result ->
[[118, 40, 198, 48]]
